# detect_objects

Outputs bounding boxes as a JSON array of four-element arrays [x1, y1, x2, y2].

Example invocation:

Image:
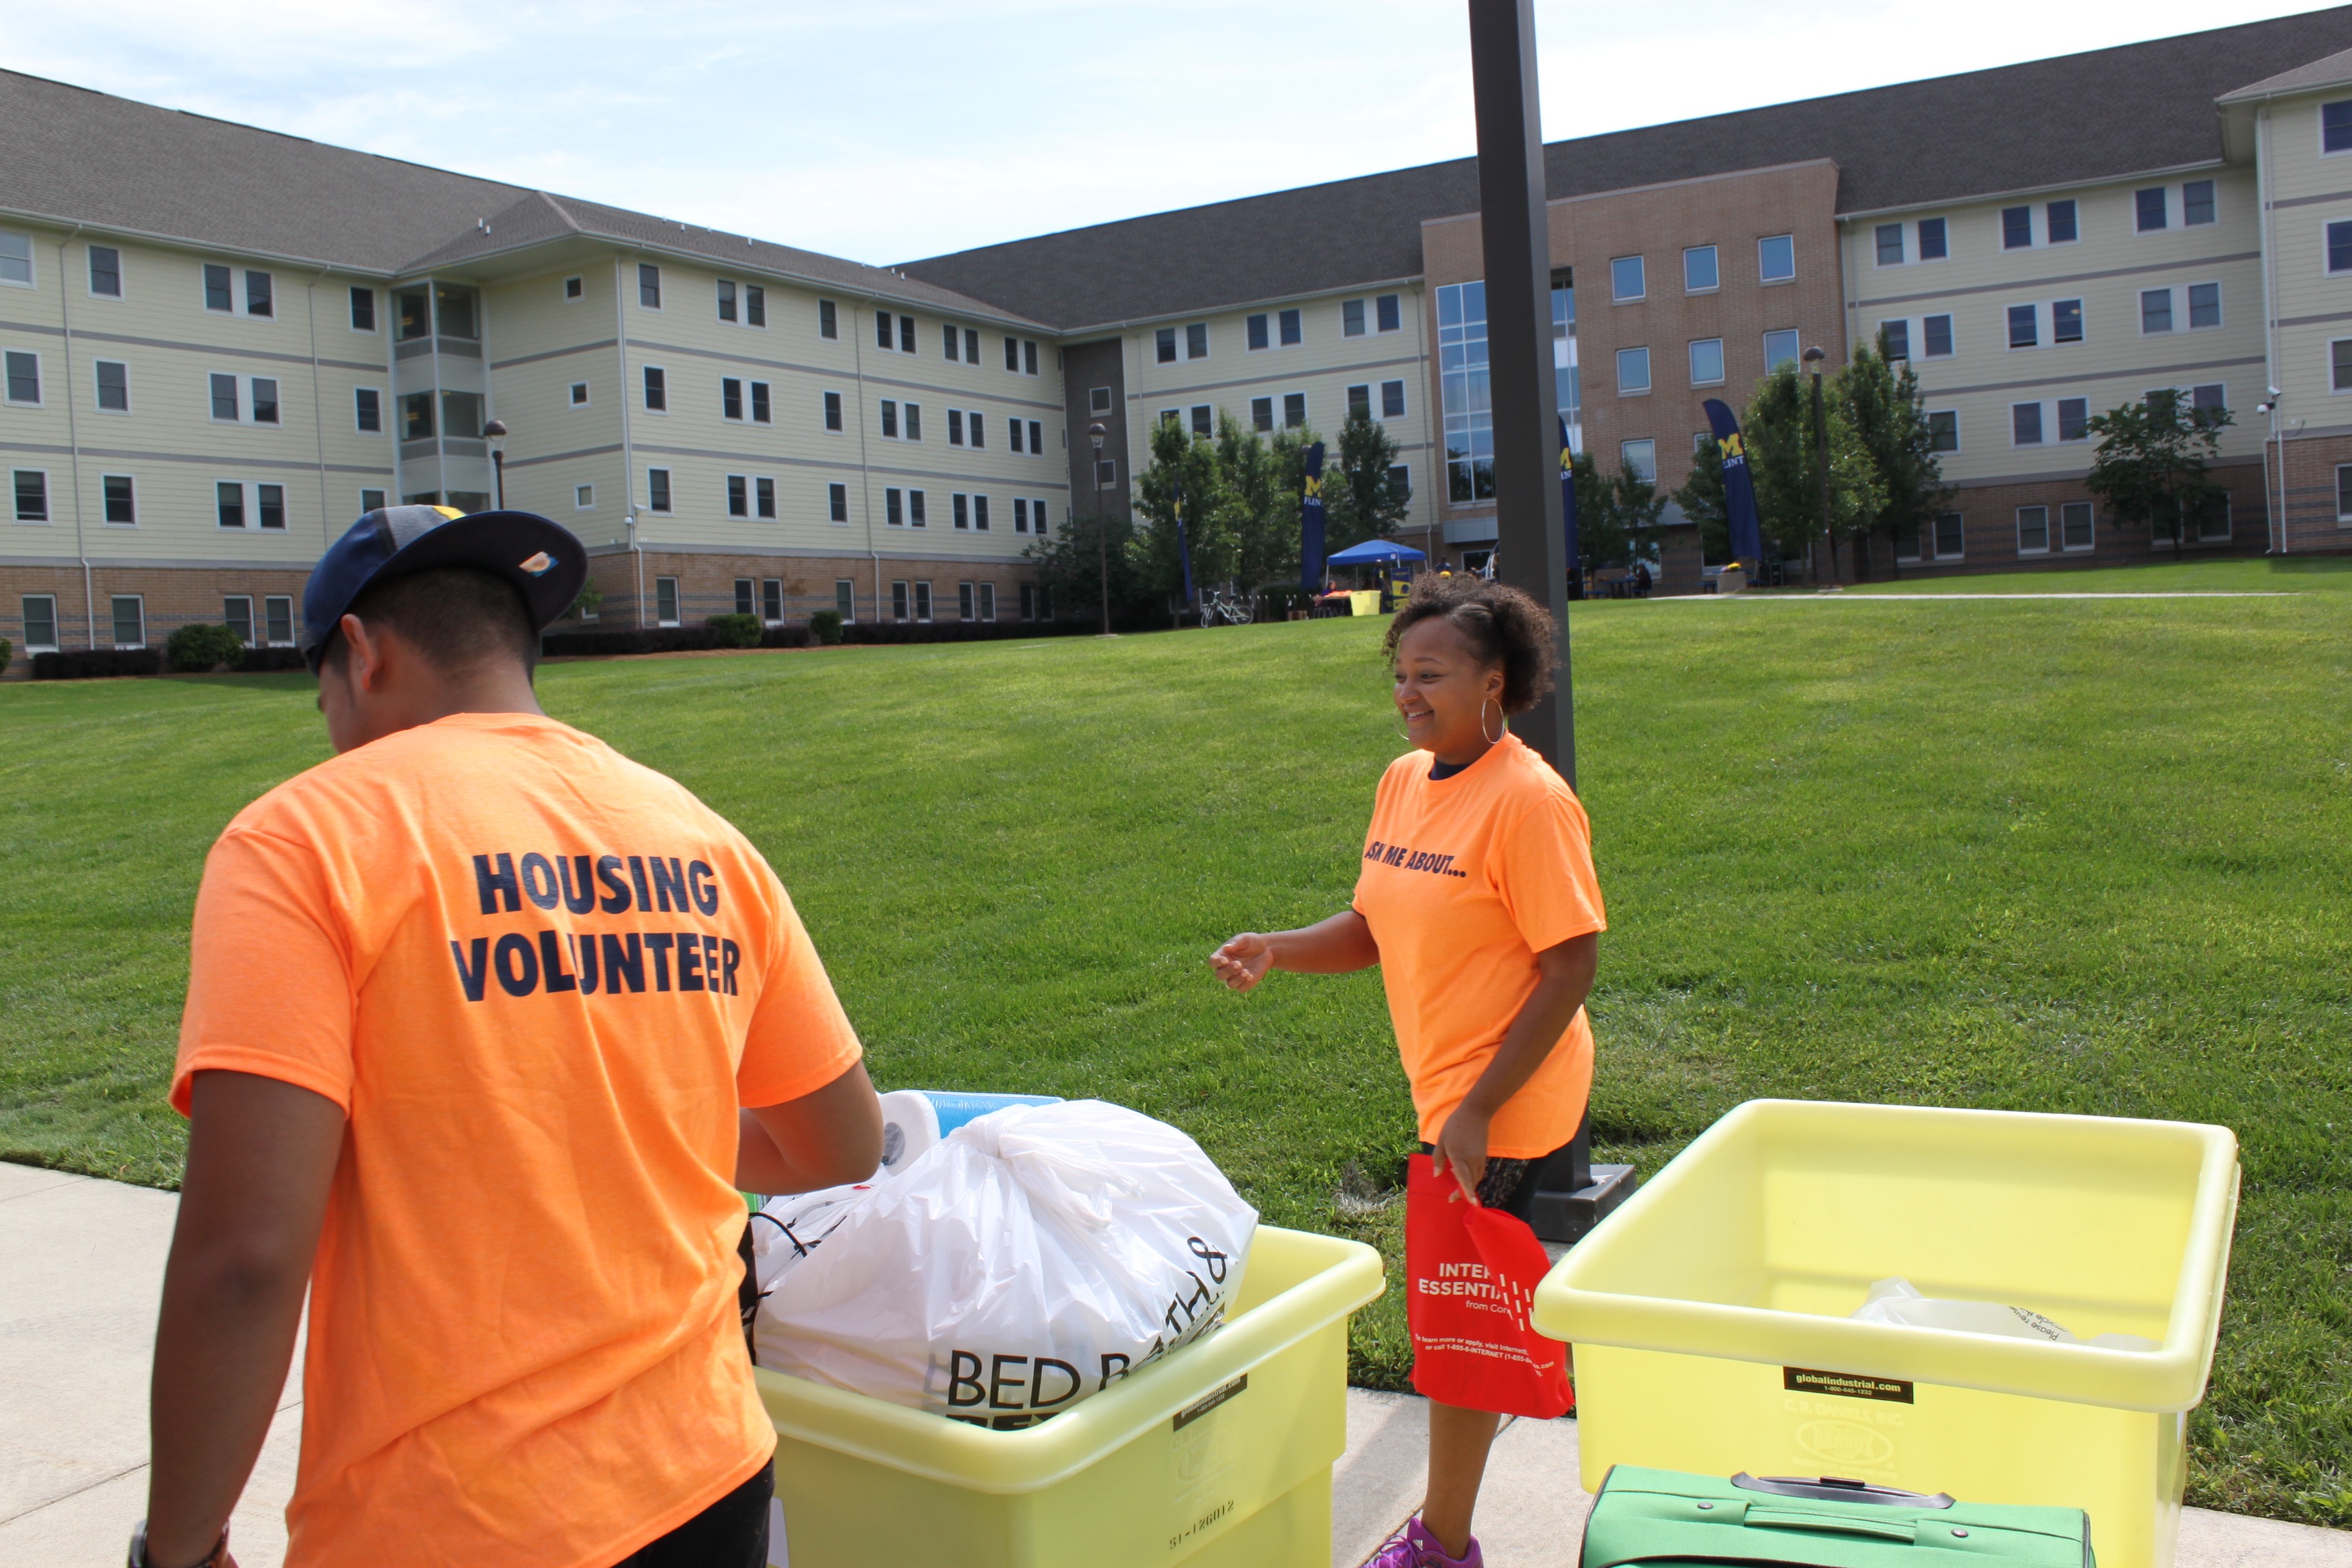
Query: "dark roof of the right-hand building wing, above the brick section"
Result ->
[[901, 7, 2352, 329]]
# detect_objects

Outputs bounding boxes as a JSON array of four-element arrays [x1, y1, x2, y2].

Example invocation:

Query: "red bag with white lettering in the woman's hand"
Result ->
[[1404, 1154, 1576, 1420]]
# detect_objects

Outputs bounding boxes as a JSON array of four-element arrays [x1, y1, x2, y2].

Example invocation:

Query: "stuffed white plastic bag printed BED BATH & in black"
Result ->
[[753, 1100, 1258, 1427]]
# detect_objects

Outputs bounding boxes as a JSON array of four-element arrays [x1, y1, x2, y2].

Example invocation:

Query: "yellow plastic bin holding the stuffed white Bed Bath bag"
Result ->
[[757, 1225, 1383, 1568]]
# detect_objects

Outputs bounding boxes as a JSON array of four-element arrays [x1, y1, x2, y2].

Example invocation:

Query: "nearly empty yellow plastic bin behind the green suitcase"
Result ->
[[1533, 1100, 2237, 1568]]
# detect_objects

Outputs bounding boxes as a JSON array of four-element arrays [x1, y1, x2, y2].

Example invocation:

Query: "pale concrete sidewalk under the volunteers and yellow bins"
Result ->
[[0, 1164, 2352, 1568]]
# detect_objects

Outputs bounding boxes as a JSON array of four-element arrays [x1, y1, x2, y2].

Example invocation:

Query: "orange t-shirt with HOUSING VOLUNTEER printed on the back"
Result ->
[[172, 713, 858, 1568]]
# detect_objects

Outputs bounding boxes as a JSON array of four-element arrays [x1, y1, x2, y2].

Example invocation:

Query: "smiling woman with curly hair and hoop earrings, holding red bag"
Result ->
[[1211, 578, 1606, 1568]]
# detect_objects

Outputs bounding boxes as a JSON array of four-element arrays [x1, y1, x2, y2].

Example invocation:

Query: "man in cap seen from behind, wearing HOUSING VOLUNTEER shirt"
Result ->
[[132, 508, 882, 1568]]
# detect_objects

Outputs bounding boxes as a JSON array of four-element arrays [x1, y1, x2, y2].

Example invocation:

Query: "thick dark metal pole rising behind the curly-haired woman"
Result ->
[[1470, 0, 1576, 785]]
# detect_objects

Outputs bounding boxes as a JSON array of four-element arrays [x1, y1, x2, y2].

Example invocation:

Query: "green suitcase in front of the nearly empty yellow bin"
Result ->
[[1576, 1465, 2098, 1568]]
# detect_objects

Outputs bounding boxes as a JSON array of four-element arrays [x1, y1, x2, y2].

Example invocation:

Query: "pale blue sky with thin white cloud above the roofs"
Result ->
[[0, 0, 2312, 263]]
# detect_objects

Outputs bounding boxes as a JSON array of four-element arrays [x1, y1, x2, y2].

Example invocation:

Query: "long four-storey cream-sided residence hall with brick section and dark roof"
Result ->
[[0, 7, 2352, 670]]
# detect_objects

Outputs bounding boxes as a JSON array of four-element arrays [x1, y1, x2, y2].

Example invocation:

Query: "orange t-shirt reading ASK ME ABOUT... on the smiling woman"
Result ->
[[1355, 734, 1609, 1159]]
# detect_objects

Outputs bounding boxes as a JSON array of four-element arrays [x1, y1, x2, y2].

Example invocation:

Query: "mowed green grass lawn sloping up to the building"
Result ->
[[0, 583, 2352, 1526]]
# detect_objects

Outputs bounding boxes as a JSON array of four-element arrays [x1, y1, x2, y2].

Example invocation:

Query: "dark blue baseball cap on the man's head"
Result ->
[[301, 506, 588, 674]]
